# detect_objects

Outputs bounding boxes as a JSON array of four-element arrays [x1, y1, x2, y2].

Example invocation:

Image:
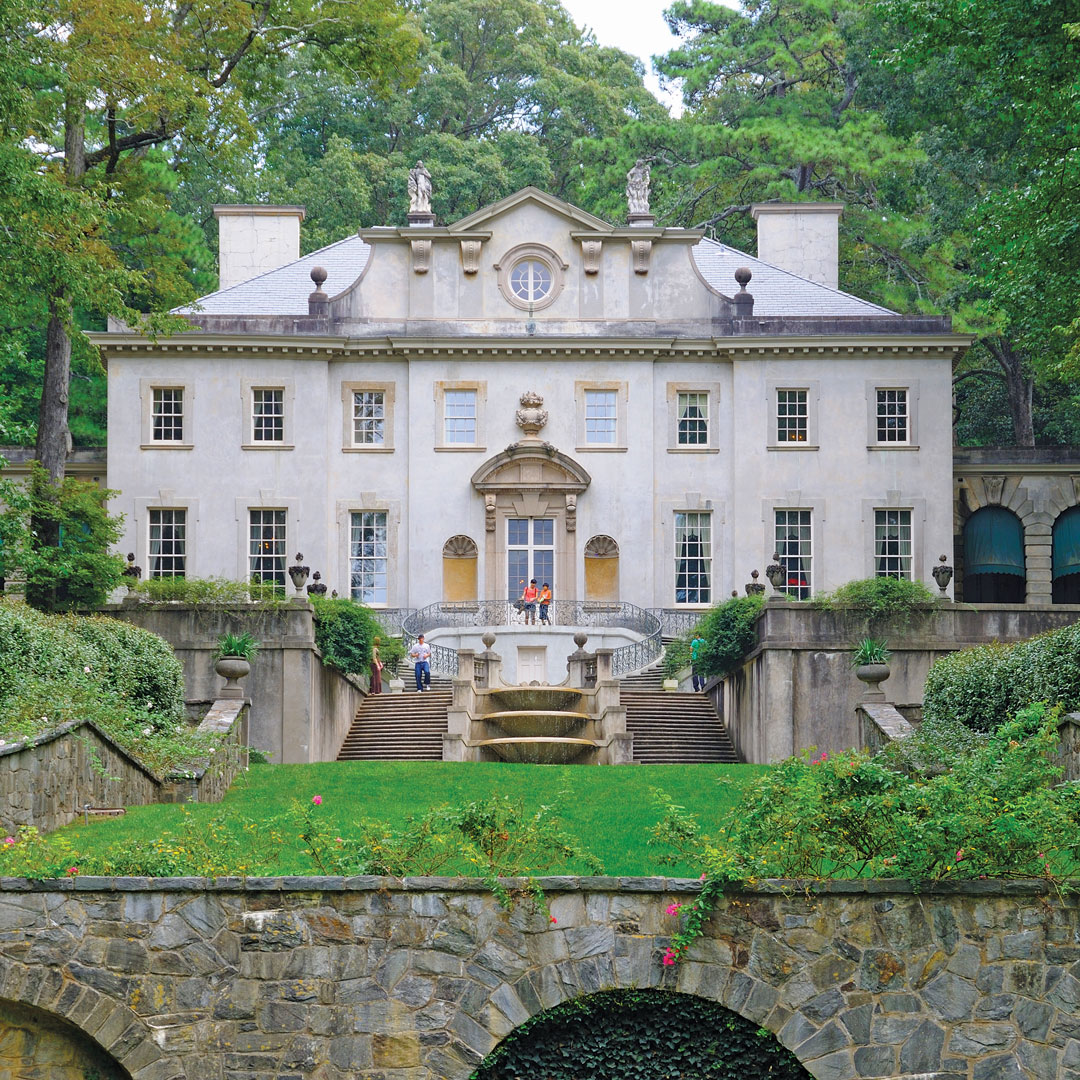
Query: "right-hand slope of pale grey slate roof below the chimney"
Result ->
[[693, 238, 895, 318]]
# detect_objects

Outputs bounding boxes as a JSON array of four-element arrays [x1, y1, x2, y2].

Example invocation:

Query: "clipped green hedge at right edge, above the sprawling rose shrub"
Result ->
[[923, 623, 1080, 731]]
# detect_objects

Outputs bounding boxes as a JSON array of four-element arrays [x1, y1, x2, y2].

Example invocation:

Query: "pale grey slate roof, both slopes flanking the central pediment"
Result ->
[[176, 235, 893, 318]]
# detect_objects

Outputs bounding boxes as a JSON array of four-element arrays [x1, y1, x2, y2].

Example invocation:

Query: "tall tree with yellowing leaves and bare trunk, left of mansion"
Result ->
[[0, 0, 415, 483]]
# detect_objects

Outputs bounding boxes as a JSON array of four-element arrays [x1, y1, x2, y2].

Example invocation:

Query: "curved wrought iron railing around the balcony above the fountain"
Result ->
[[402, 600, 663, 676]]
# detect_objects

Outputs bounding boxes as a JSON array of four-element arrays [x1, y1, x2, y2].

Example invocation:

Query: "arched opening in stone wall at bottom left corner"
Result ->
[[0, 1001, 131, 1080]]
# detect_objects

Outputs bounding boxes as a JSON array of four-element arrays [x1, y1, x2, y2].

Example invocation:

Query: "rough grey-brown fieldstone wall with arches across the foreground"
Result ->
[[0, 878, 1080, 1080]]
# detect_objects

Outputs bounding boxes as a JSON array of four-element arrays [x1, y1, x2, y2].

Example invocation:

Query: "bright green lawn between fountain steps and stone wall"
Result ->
[[52, 761, 766, 877]]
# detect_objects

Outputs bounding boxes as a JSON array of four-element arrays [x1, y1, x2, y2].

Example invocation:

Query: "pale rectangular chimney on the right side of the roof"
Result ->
[[751, 203, 843, 288]]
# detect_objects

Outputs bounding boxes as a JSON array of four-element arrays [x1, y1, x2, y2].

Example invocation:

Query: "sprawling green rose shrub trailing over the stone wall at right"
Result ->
[[653, 704, 1080, 961]]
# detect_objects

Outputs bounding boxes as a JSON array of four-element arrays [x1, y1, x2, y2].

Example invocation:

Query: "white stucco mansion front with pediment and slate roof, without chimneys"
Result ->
[[97, 189, 968, 608]]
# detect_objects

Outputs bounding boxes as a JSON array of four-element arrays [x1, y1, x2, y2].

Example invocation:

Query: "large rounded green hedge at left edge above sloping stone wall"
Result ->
[[0, 600, 184, 726]]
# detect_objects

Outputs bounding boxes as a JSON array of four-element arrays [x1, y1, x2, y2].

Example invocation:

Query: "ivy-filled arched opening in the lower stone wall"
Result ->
[[473, 990, 810, 1080]]
